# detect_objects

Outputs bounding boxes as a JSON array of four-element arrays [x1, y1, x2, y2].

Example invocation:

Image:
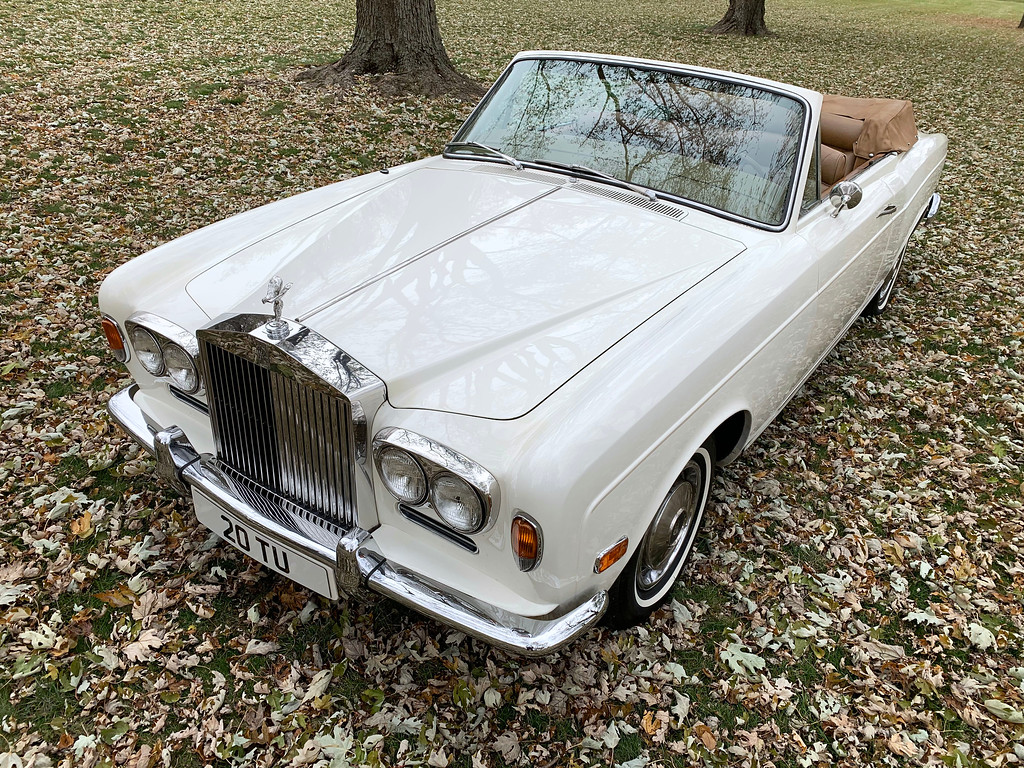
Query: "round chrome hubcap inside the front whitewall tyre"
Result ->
[[637, 461, 701, 590]]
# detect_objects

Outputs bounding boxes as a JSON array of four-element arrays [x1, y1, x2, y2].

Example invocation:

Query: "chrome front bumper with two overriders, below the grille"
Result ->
[[108, 385, 608, 655]]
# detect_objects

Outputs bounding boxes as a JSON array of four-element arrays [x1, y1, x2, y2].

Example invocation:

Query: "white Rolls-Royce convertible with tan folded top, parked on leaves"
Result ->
[[99, 51, 946, 654]]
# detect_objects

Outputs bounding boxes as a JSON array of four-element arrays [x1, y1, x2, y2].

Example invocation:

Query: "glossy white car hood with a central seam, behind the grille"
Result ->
[[186, 161, 743, 419]]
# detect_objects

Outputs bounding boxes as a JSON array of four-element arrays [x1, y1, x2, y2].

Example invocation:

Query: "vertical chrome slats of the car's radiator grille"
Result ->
[[201, 341, 355, 527]]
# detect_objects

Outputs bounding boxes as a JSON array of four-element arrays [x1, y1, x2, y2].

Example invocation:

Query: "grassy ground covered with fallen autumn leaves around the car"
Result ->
[[0, 0, 1024, 768]]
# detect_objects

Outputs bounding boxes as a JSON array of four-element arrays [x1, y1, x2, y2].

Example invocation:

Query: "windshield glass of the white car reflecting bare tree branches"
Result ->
[[456, 58, 804, 226]]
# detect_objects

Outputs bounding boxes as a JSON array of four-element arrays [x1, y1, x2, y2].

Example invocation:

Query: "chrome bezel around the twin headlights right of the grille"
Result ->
[[373, 427, 501, 536]]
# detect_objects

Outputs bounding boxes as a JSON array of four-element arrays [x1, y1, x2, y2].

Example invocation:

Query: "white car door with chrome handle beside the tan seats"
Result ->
[[797, 157, 896, 360]]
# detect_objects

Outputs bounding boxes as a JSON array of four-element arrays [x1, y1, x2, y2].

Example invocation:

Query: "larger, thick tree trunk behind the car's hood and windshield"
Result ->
[[298, 0, 483, 98]]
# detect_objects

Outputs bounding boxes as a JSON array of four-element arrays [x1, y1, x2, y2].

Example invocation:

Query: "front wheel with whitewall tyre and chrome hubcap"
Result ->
[[604, 440, 715, 629]]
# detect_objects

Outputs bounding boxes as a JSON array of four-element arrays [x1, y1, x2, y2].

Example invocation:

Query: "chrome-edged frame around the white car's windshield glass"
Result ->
[[442, 51, 812, 232]]
